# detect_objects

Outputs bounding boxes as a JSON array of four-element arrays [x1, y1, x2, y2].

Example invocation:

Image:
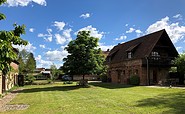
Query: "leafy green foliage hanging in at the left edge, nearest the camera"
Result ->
[[0, 0, 28, 75]]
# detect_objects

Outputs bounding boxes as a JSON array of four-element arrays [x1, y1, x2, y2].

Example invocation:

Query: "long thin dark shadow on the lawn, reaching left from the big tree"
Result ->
[[19, 85, 89, 93]]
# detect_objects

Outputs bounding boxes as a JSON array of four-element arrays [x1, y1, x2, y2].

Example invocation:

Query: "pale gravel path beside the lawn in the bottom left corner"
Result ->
[[0, 90, 29, 112]]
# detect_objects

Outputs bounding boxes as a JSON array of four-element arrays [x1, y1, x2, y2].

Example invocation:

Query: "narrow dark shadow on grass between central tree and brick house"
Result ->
[[89, 82, 134, 89]]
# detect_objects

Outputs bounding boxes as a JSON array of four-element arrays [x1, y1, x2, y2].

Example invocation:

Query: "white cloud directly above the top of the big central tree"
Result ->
[[75, 25, 104, 39]]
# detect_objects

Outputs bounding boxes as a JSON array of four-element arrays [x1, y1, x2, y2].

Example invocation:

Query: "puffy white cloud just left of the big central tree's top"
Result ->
[[55, 29, 72, 44]]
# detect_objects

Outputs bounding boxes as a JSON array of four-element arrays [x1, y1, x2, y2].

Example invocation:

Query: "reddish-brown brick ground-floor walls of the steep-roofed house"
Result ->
[[108, 59, 169, 85]]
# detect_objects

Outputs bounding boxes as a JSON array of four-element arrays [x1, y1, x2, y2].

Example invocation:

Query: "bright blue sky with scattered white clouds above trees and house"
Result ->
[[0, 0, 185, 68]]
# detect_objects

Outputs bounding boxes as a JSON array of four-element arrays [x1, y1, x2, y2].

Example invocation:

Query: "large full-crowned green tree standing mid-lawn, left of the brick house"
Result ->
[[63, 31, 105, 79]]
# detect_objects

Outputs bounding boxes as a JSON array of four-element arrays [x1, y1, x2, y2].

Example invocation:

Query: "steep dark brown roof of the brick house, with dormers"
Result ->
[[106, 29, 178, 63]]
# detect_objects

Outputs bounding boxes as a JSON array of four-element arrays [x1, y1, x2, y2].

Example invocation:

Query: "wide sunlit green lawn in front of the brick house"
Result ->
[[3, 83, 185, 114]]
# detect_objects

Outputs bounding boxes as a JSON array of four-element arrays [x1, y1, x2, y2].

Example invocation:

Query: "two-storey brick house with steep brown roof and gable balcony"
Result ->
[[106, 29, 178, 85]]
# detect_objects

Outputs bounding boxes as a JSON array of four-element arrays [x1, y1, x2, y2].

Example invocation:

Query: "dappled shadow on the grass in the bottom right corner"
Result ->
[[137, 92, 185, 114]]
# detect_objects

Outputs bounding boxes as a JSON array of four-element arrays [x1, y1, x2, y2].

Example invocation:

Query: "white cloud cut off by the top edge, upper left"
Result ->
[[7, 0, 46, 7]]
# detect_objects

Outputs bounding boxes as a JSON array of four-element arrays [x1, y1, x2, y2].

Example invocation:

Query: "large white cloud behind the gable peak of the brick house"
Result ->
[[146, 16, 185, 43]]
